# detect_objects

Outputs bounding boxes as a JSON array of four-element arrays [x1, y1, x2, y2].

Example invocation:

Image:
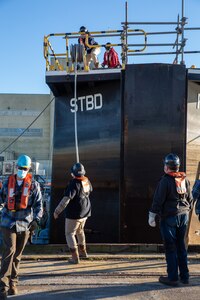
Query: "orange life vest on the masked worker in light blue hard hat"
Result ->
[[7, 174, 32, 211]]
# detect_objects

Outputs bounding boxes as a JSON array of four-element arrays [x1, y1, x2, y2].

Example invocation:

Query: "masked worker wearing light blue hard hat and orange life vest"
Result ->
[[0, 154, 43, 299]]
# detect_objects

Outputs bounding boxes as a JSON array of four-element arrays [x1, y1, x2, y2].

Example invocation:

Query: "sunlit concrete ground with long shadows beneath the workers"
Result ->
[[9, 253, 200, 300]]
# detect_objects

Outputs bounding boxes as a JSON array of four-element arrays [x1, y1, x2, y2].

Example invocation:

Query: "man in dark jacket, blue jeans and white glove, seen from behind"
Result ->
[[148, 153, 193, 286]]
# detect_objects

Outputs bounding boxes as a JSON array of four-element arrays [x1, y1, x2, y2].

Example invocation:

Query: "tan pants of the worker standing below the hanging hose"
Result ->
[[65, 218, 87, 249]]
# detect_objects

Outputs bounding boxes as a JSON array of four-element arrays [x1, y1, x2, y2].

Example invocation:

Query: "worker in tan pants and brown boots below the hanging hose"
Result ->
[[54, 163, 92, 264]]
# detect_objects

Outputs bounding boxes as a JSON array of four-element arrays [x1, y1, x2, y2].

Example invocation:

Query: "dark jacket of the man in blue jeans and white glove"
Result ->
[[150, 174, 193, 218]]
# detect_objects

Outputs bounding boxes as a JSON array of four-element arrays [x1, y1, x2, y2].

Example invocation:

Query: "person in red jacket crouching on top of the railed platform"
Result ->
[[101, 43, 121, 68]]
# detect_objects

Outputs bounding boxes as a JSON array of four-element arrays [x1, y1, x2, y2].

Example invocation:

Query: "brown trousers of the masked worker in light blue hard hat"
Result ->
[[0, 227, 30, 290]]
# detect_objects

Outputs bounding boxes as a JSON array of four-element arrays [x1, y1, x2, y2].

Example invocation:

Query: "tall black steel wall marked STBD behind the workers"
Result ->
[[46, 64, 187, 243]]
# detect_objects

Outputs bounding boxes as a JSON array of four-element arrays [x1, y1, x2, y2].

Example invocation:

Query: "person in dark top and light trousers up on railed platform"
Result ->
[[78, 26, 101, 68]]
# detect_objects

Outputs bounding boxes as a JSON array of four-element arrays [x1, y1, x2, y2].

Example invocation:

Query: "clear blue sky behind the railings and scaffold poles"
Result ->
[[0, 0, 200, 94]]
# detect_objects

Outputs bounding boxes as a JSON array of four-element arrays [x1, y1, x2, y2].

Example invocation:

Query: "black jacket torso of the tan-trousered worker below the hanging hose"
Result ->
[[64, 177, 92, 219]]
